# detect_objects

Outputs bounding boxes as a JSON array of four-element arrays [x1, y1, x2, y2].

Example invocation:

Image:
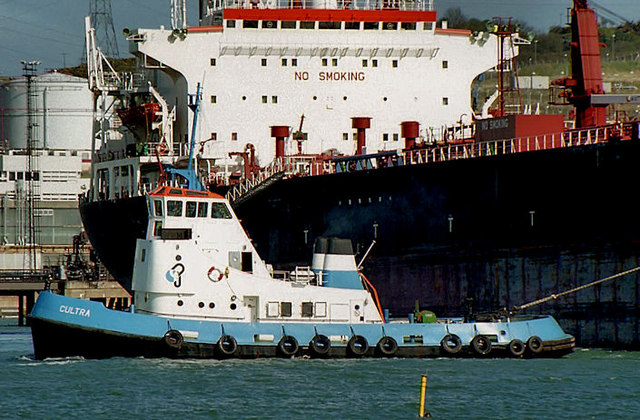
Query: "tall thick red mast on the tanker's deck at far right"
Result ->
[[554, 0, 607, 128]]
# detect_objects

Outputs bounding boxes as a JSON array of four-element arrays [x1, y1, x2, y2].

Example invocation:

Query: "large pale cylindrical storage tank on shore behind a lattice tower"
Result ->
[[0, 71, 93, 150]]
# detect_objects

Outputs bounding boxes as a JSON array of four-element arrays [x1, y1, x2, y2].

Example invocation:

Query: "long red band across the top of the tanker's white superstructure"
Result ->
[[224, 9, 436, 22]]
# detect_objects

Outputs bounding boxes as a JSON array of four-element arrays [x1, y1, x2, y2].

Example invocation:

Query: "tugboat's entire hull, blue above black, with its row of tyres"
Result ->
[[30, 292, 574, 359]]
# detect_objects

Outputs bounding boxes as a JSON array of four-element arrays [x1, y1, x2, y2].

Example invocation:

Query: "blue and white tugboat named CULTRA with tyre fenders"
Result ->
[[30, 186, 574, 359]]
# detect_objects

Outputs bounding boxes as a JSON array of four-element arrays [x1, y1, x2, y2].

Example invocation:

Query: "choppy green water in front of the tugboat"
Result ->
[[0, 325, 640, 420]]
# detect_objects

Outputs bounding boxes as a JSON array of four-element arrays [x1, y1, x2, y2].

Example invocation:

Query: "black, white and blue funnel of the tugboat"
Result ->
[[311, 238, 363, 289]]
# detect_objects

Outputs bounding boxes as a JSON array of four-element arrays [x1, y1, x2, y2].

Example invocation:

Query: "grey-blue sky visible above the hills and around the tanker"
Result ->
[[0, 0, 640, 76]]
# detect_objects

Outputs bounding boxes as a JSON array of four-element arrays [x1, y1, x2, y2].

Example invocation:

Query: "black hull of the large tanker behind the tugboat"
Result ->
[[81, 141, 640, 348]]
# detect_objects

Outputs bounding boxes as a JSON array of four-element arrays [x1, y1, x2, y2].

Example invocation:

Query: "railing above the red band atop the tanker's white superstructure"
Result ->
[[208, 0, 433, 11]]
